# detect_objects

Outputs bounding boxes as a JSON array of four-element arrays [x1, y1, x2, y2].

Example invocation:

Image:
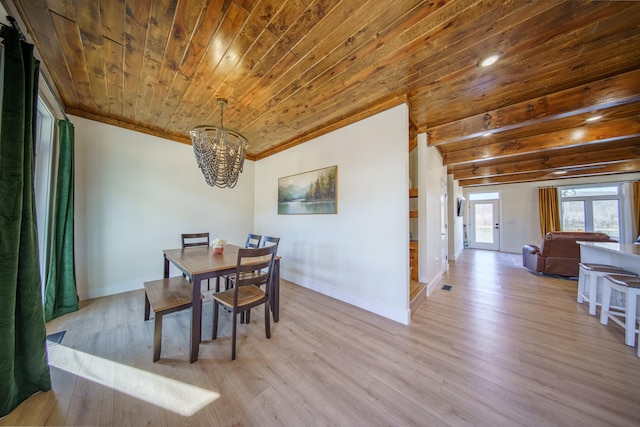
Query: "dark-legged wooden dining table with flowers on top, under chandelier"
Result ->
[[162, 244, 280, 363]]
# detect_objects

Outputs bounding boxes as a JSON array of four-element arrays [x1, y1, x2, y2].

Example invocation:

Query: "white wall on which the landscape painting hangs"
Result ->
[[254, 105, 409, 323]]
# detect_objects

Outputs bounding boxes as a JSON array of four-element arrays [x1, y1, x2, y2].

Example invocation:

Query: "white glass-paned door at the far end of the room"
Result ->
[[469, 200, 500, 251]]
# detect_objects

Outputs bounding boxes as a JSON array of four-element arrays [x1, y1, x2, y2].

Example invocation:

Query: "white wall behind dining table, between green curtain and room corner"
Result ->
[[70, 117, 254, 299]]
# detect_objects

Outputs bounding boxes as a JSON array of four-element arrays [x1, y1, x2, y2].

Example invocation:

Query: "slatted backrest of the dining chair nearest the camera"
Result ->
[[235, 245, 278, 296]]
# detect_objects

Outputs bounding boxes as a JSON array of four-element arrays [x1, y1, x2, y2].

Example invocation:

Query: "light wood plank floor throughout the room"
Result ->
[[0, 250, 640, 427]]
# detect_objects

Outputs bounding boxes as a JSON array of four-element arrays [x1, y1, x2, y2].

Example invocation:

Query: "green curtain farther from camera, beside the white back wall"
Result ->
[[44, 120, 78, 322]]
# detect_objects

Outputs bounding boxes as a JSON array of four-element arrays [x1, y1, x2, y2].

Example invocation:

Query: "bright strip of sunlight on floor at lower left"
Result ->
[[48, 344, 220, 417]]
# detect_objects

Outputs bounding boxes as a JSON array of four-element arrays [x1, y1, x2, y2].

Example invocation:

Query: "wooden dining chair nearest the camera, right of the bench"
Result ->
[[211, 245, 278, 360]]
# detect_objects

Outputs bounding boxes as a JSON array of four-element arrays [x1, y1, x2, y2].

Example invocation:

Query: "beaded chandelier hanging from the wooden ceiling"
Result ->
[[189, 98, 247, 188]]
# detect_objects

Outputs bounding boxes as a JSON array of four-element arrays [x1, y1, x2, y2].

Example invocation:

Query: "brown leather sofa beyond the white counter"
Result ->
[[522, 231, 616, 277]]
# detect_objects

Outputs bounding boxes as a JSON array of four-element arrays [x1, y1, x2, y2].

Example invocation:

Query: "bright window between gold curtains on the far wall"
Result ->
[[559, 184, 621, 240]]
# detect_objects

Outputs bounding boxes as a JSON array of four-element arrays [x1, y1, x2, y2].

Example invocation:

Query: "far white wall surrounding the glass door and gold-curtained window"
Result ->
[[464, 173, 640, 253]]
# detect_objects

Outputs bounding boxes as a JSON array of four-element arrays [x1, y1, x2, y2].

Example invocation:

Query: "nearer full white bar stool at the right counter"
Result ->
[[600, 274, 640, 347]]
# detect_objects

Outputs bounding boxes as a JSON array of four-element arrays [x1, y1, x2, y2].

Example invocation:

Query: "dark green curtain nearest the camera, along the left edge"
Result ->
[[0, 25, 51, 417]]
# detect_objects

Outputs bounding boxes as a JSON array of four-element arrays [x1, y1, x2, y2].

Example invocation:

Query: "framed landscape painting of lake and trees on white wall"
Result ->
[[278, 166, 338, 215]]
